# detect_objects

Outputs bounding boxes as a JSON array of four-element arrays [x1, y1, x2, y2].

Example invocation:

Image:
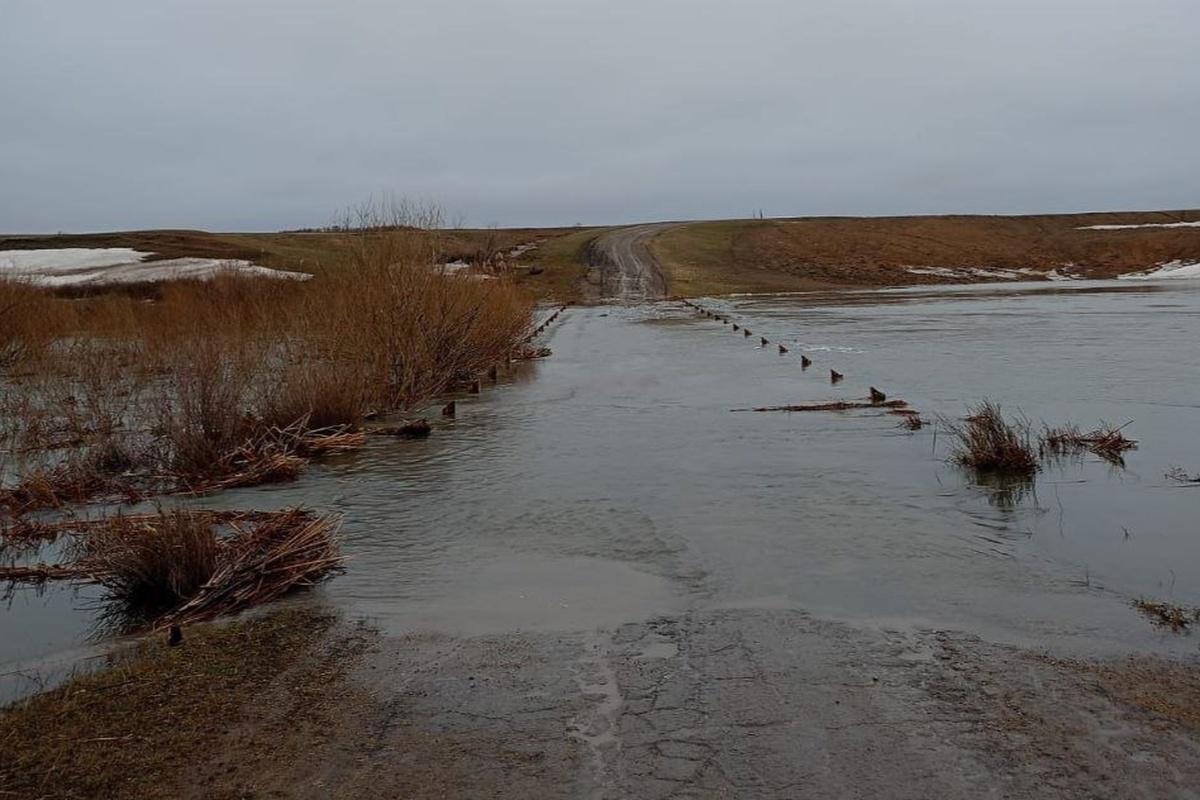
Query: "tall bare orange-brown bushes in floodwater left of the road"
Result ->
[[0, 207, 533, 512]]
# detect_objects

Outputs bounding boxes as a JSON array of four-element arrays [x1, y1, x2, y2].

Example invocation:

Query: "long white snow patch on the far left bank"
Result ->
[[0, 247, 312, 287]]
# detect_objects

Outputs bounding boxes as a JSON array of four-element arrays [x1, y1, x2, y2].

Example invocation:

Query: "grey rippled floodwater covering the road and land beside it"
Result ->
[[0, 281, 1200, 694]]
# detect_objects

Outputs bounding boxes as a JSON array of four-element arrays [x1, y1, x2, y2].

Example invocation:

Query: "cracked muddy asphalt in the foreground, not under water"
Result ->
[[196, 608, 1200, 800]]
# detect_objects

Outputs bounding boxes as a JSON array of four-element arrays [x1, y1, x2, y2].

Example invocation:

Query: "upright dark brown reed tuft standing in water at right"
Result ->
[[943, 401, 1040, 477]]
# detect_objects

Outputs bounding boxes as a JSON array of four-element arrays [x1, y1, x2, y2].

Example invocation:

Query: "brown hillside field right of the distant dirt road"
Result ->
[[653, 211, 1200, 295]]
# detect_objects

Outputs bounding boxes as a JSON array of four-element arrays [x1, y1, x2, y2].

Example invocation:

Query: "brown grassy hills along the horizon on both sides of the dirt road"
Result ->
[[0, 210, 1200, 302]]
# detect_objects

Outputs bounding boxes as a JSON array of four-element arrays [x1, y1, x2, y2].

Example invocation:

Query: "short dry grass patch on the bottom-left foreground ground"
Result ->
[[0, 609, 352, 800]]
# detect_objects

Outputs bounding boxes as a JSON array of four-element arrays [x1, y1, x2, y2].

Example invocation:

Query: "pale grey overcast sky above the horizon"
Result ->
[[0, 0, 1200, 231]]
